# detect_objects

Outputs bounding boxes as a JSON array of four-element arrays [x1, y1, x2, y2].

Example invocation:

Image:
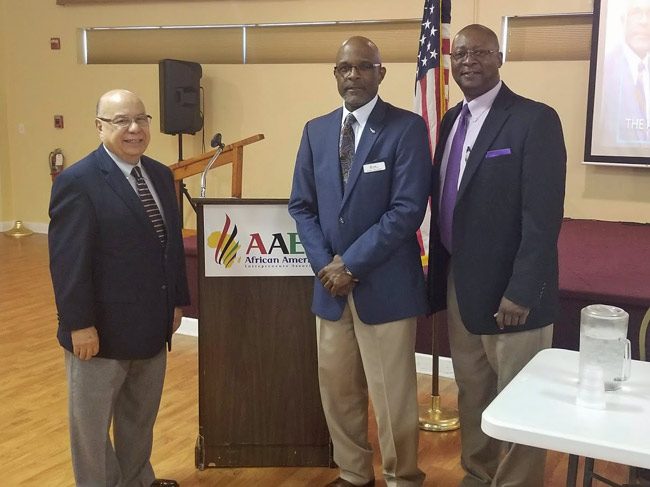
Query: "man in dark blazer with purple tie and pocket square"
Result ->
[[429, 25, 566, 487]]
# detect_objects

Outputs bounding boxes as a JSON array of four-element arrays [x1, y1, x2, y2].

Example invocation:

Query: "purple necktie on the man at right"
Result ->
[[440, 103, 471, 253]]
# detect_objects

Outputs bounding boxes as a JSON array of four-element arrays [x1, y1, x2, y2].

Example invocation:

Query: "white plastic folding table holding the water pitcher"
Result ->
[[481, 348, 650, 486]]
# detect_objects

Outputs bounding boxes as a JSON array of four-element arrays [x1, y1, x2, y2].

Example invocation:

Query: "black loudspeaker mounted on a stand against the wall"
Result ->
[[158, 59, 203, 135]]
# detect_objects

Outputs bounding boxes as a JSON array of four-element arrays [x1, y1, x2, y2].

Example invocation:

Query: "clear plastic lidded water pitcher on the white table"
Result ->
[[580, 304, 632, 391]]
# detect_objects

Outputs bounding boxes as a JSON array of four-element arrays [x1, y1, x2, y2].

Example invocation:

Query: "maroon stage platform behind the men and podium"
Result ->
[[184, 219, 650, 358]]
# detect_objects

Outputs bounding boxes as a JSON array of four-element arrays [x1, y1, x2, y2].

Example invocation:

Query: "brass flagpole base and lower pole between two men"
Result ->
[[419, 314, 460, 432]]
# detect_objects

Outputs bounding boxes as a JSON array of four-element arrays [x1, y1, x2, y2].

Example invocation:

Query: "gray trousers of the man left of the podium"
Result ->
[[65, 348, 167, 487]]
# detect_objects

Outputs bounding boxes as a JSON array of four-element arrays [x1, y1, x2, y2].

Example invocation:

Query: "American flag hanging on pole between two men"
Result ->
[[415, 0, 451, 264]]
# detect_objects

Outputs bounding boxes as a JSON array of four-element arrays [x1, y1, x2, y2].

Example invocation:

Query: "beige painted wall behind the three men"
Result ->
[[0, 0, 650, 226]]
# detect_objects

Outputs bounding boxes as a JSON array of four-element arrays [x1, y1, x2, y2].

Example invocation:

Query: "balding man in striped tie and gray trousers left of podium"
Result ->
[[49, 90, 189, 487]]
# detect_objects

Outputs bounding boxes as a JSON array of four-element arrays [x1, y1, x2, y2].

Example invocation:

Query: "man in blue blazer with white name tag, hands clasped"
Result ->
[[289, 37, 431, 487]]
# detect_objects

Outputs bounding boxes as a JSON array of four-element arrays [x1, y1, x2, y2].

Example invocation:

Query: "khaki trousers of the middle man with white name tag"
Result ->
[[316, 295, 424, 487]]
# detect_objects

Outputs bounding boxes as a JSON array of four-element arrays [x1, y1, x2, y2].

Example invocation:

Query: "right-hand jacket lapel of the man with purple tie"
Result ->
[[456, 84, 512, 201]]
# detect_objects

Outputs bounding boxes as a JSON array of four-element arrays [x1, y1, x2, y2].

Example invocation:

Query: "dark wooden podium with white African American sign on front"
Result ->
[[194, 198, 332, 469]]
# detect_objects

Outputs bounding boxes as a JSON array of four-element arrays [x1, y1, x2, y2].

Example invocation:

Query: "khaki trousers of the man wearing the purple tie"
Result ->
[[447, 272, 553, 487]]
